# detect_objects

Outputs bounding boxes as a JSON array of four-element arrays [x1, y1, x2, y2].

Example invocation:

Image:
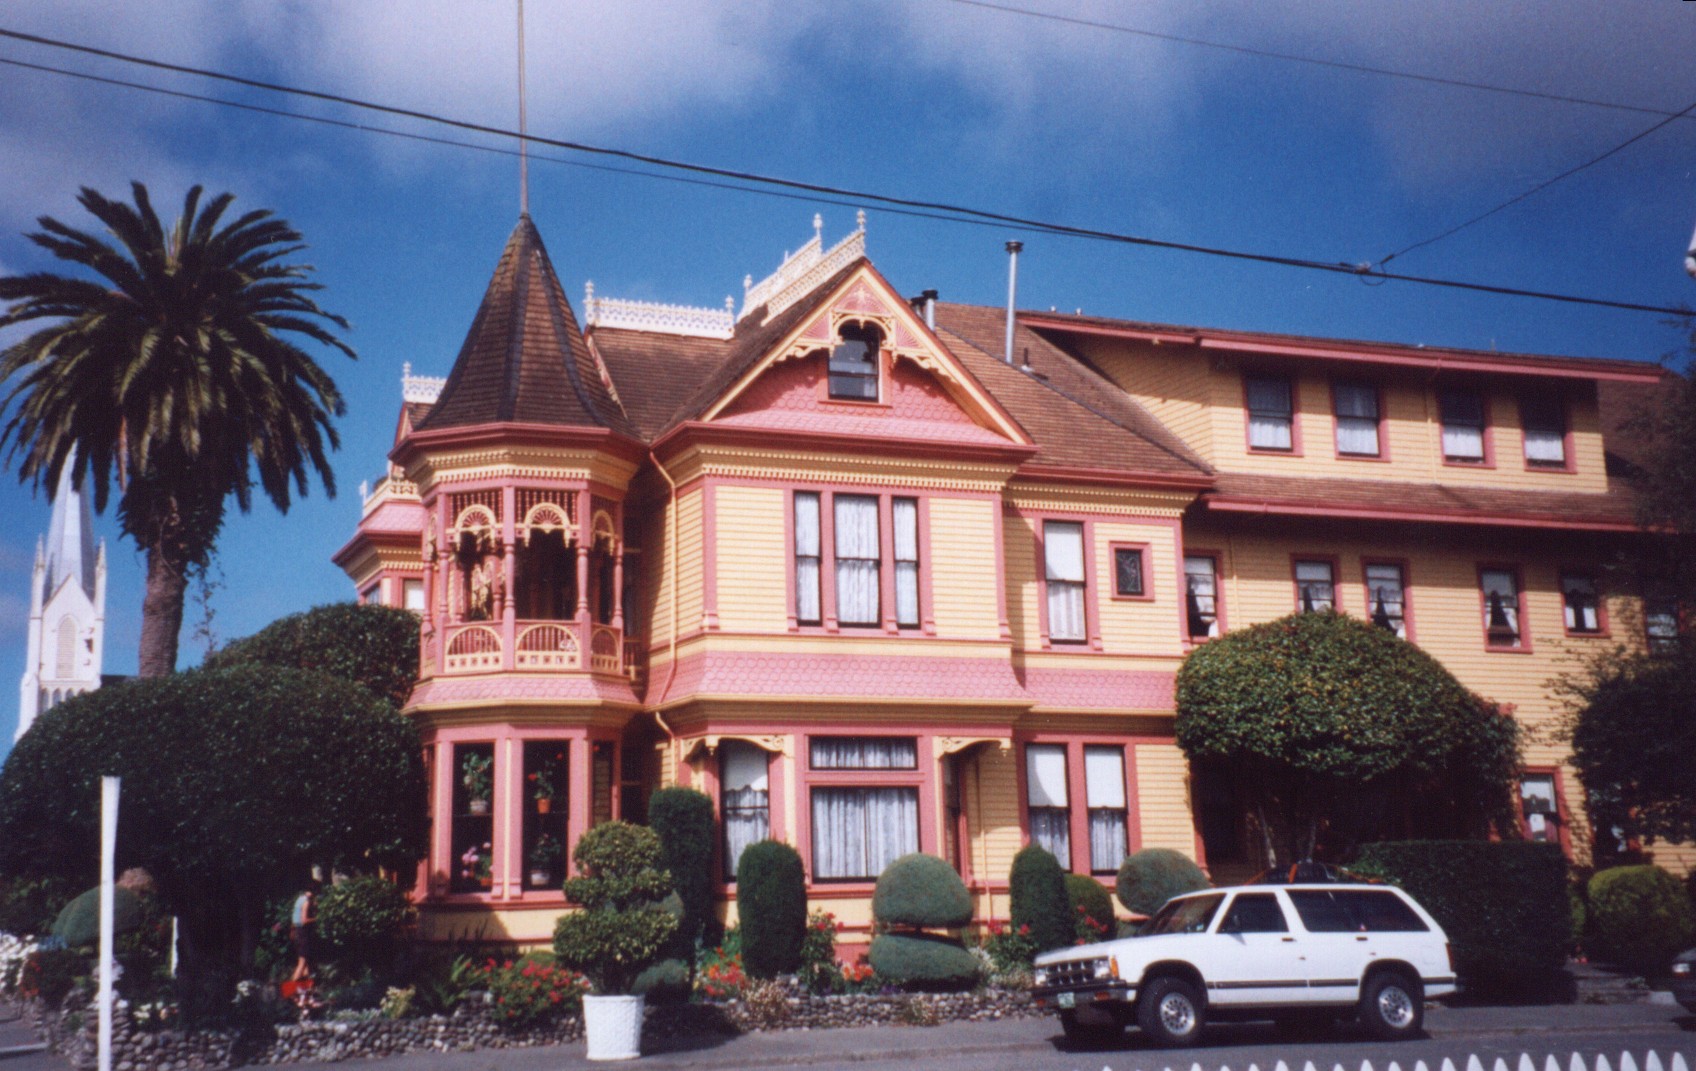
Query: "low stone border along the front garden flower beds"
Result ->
[[0, 984, 1045, 1071]]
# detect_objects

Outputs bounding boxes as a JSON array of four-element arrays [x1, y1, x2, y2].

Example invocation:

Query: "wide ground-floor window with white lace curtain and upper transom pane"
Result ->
[[807, 737, 919, 881]]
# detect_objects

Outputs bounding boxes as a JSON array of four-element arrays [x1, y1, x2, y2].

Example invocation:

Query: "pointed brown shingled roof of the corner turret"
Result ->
[[419, 216, 634, 436]]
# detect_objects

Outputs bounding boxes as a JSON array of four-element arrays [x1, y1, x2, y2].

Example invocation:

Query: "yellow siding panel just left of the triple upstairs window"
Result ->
[[714, 485, 789, 633]]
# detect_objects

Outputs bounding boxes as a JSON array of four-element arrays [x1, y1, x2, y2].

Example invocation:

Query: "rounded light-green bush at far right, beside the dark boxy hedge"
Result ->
[[1589, 866, 1696, 976]]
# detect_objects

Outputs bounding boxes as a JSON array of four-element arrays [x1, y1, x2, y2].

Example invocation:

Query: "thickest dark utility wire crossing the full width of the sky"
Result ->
[[0, 27, 1689, 316]]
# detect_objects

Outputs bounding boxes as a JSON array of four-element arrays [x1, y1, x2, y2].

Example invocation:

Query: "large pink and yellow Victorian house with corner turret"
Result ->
[[336, 209, 1689, 940]]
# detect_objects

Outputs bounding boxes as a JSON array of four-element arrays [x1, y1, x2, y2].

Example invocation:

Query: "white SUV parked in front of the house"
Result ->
[[1033, 884, 1455, 1046]]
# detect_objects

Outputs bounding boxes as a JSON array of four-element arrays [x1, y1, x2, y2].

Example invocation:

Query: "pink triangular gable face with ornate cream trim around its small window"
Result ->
[[702, 263, 1029, 445]]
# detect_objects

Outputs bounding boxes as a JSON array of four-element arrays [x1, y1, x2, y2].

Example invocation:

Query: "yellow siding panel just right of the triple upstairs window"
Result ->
[[929, 497, 1001, 640]]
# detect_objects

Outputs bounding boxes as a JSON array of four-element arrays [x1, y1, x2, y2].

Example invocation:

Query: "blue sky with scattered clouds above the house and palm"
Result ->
[[0, 0, 1696, 749]]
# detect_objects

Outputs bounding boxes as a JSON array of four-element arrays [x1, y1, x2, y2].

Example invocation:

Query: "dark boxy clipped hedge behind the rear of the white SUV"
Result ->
[[1352, 840, 1572, 993]]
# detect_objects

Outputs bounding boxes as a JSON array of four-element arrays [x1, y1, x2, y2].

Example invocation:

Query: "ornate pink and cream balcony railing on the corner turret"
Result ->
[[426, 621, 643, 681]]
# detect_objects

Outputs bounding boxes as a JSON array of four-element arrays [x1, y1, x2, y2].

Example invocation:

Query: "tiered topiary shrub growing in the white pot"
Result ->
[[553, 821, 677, 995]]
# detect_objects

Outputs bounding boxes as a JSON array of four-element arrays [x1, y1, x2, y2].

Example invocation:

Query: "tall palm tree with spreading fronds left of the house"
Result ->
[[0, 182, 354, 677]]
